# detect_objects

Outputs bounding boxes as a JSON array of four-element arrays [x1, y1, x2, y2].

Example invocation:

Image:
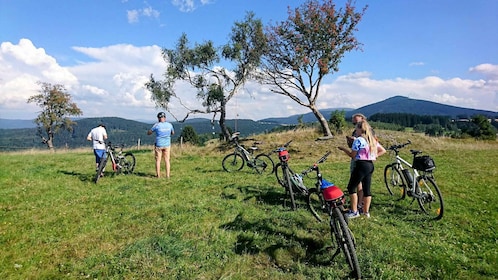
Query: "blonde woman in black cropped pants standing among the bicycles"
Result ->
[[338, 120, 386, 218]]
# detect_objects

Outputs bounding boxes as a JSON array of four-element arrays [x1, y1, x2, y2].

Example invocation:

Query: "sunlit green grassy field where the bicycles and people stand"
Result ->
[[0, 130, 498, 279]]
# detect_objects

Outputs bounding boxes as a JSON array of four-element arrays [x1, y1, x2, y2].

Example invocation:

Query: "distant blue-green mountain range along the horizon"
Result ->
[[0, 96, 498, 150]]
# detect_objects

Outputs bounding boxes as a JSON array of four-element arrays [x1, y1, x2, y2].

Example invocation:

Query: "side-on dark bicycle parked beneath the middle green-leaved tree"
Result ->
[[221, 132, 275, 174]]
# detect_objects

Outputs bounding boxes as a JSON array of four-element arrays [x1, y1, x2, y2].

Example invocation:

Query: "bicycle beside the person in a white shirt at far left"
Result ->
[[94, 142, 136, 184]]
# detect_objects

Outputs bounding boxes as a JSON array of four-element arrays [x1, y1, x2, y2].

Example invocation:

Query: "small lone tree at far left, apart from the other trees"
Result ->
[[27, 82, 83, 150]]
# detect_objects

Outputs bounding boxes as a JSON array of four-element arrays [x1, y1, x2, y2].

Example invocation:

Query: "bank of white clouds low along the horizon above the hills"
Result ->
[[0, 39, 498, 121]]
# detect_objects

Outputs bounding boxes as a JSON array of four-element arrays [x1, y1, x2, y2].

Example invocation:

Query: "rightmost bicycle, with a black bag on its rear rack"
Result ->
[[384, 140, 444, 220]]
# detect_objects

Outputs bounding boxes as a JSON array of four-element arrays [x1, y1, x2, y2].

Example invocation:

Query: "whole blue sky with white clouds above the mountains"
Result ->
[[0, 0, 498, 121]]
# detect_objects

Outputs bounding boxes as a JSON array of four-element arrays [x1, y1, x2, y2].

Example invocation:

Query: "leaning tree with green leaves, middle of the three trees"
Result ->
[[145, 12, 266, 139]]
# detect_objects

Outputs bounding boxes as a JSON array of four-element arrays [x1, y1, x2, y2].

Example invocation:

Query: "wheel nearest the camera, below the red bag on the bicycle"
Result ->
[[330, 207, 361, 279]]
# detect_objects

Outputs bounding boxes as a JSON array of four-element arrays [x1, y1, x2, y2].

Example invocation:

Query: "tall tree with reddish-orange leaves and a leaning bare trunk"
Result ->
[[260, 0, 367, 137]]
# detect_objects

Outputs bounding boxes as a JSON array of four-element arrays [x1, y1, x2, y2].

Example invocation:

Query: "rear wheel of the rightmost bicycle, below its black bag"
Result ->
[[417, 175, 444, 220]]
